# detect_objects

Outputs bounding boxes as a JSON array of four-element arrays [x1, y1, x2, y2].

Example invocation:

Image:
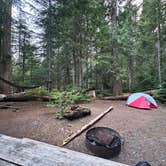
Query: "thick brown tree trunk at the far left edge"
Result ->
[[0, 0, 12, 94]]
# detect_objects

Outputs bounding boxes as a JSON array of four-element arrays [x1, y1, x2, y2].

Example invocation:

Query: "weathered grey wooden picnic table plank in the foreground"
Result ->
[[0, 135, 127, 166]]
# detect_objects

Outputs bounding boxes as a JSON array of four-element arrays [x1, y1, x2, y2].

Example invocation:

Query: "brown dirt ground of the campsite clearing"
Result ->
[[0, 100, 166, 166]]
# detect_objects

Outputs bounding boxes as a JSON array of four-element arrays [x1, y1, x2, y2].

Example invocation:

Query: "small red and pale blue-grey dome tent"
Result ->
[[126, 93, 158, 109]]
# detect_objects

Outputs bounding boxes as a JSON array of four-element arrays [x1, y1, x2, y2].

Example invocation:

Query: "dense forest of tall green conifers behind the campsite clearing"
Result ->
[[0, 0, 166, 95]]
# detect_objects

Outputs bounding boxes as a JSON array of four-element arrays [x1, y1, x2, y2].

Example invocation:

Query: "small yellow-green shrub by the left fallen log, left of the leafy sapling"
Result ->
[[26, 86, 49, 96]]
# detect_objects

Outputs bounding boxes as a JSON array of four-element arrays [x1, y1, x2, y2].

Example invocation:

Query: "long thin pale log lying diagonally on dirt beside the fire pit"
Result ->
[[62, 106, 113, 146]]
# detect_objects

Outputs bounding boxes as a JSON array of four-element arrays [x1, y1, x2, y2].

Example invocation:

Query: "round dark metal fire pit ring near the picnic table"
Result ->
[[86, 127, 121, 158]]
